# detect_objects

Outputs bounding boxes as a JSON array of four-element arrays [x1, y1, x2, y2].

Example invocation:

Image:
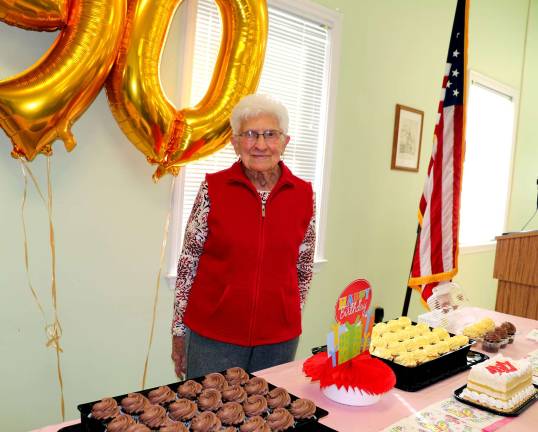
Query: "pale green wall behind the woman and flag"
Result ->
[[0, 0, 538, 431]]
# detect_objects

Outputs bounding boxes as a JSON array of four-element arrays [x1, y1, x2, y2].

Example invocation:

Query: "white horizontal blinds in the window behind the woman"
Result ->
[[181, 0, 330, 240]]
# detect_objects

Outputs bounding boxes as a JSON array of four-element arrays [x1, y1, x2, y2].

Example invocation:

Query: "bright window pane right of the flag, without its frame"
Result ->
[[460, 72, 516, 247]]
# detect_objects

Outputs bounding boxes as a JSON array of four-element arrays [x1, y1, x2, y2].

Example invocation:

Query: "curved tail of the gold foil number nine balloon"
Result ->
[[0, 0, 127, 160]]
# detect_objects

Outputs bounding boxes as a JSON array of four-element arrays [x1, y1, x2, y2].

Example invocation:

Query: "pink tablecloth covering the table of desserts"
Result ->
[[34, 308, 538, 432]]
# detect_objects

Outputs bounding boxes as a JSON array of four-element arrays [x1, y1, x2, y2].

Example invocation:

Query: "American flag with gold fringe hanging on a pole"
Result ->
[[408, 0, 469, 301]]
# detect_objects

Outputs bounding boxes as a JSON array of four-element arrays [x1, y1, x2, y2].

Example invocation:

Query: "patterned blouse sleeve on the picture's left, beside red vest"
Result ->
[[172, 181, 209, 336]]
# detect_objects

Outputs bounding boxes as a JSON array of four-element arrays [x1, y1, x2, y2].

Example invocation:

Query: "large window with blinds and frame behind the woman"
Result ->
[[168, 0, 341, 279]]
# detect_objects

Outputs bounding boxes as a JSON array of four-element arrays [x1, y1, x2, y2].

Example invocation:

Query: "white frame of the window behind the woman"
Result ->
[[166, 0, 342, 289]]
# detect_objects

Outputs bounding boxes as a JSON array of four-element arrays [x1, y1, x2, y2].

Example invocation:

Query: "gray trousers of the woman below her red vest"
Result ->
[[186, 329, 299, 379]]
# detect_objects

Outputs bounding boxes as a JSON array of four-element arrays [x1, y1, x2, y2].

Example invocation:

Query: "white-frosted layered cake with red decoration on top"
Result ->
[[460, 354, 536, 412]]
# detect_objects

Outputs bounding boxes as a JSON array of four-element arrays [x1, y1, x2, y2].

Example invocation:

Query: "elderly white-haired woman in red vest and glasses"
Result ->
[[172, 95, 315, 378]]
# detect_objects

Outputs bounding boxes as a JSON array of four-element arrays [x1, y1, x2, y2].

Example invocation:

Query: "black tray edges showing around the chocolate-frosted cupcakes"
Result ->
[[75, 371, 326, 432]]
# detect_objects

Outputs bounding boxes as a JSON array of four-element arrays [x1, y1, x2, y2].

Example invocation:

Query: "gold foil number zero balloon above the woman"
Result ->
[[107, 0, 267, 179]]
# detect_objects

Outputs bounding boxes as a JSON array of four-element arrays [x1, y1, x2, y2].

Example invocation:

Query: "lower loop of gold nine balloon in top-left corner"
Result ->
[[0, 0, 68, 31]]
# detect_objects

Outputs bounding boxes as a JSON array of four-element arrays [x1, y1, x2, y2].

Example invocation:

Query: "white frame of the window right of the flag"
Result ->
[[459, 70, 519, 255]]
